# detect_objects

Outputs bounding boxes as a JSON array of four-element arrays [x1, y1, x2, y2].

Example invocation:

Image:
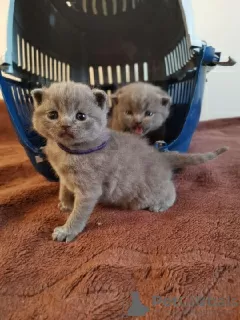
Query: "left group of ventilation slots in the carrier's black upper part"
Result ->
[[17, 35, 70, 81]]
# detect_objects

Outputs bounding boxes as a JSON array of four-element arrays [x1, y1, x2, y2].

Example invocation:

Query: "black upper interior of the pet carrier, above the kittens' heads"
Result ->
[[13, 0, 195, 91]]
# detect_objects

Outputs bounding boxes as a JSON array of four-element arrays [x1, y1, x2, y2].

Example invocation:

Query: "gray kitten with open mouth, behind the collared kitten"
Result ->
[[109, 82, 171, 140]]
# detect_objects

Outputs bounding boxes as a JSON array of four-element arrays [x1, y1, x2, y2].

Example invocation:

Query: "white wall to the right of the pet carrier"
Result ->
[[192, 0, 240, 120]]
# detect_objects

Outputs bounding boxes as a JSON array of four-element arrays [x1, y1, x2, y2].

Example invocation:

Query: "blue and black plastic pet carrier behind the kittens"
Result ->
[[0, 0, 236, 180]]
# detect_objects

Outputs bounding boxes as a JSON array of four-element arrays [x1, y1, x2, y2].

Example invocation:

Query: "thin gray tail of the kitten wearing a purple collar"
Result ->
[[163, 147, 229, 169]]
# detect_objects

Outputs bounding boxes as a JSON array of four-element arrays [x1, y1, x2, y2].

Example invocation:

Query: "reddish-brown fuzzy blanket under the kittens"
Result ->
[[0, 103, 240, 320]]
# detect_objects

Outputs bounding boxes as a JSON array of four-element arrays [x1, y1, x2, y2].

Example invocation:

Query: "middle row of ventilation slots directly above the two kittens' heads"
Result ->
[[89, 62, 149, 86]]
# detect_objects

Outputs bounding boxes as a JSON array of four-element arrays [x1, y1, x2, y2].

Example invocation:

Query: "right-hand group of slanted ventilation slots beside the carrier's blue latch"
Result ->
[[164, 38, 193, 76]]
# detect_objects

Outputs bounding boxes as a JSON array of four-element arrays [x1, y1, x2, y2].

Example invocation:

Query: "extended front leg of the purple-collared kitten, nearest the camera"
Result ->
[[52, 190, 101, 242]]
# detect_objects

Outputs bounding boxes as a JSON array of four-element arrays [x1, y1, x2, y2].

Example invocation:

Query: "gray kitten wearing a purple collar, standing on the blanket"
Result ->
[[32, 82, 226, 242]]
